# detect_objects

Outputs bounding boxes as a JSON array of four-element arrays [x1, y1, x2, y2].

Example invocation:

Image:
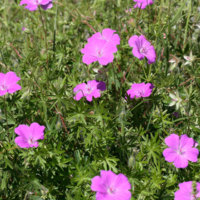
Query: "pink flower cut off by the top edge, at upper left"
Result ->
[[19, 0, 53, 11]]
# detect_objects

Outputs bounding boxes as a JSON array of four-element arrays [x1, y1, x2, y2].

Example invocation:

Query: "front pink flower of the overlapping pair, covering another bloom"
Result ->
[[81, 38, 117, 65]]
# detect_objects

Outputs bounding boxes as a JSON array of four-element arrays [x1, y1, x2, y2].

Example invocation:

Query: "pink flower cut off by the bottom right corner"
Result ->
[[174, 181, 200, 200]]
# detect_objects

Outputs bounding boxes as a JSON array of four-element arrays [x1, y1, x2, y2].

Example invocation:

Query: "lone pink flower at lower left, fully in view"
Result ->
[[15, 122, 45, 148]]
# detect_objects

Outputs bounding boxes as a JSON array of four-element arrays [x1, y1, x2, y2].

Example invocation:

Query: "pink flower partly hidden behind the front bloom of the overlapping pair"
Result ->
[[88, 28, 120, 45]]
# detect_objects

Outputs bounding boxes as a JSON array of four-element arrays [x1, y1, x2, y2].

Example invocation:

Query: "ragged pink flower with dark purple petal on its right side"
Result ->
[[73, 80, 106, 101]]
